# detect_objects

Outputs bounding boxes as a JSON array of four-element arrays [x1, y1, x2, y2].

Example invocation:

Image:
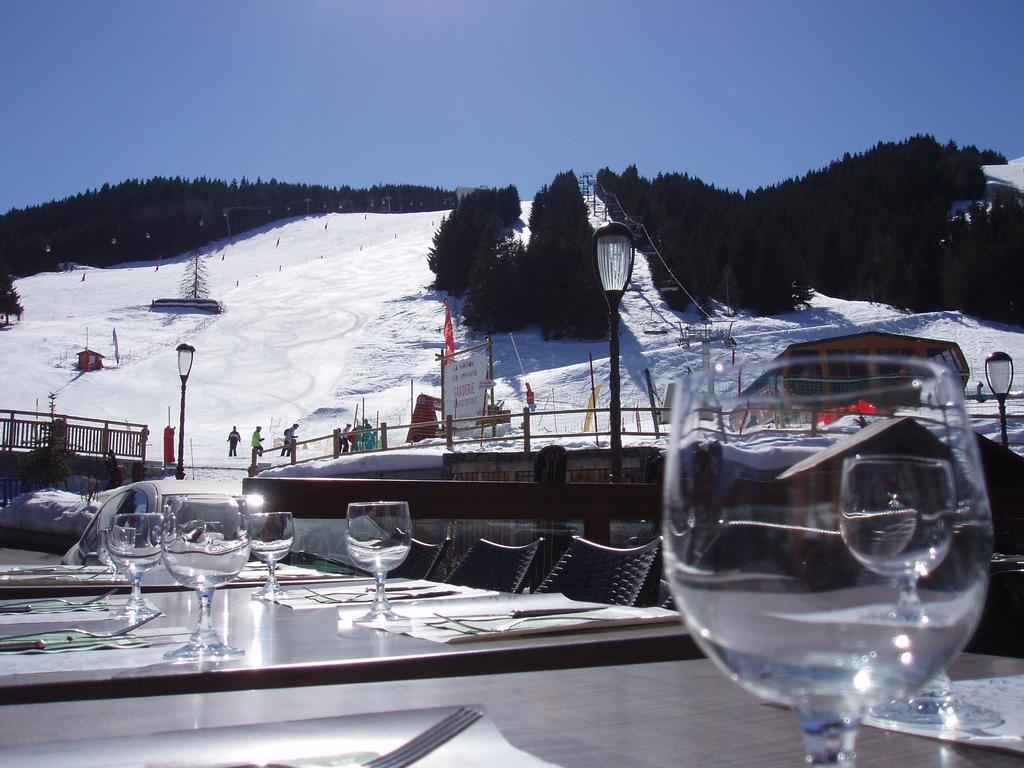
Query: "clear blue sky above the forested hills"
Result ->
[[0, 0, 1024, 212]]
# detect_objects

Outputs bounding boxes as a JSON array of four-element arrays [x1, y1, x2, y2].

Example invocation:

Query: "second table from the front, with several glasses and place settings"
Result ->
[[0, 578, 701, 703]]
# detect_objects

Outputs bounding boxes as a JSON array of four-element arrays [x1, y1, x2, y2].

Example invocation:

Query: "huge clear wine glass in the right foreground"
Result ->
[[664, 356, 991, 765]]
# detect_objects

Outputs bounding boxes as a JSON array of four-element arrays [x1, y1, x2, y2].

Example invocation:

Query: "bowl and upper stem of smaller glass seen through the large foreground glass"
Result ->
[[840, 454, 955, 622]]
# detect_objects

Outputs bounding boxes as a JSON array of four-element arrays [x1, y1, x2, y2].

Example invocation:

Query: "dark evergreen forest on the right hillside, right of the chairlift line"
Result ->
[[598, 136, 1024, 324]]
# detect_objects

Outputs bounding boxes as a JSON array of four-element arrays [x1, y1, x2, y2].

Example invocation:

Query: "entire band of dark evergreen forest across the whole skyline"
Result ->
[[0, 135, 1024, 338]]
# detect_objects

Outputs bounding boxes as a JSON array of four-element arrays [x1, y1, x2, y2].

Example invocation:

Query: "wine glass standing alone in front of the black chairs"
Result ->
[[345, 502, 412, 626]]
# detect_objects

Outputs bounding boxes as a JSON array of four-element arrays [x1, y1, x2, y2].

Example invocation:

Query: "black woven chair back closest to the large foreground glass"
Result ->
[[537, 537, 662, 605]]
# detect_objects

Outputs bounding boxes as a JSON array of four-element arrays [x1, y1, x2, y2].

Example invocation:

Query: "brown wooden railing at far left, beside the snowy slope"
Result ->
[[0, 411, 150, 462]]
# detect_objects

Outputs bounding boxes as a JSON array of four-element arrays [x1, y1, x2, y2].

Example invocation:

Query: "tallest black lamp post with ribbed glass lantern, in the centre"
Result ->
[[594, 221, 633, 482]]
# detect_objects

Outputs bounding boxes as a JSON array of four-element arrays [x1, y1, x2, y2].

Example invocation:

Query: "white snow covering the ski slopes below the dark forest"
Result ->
[[6, 192, 1024, 501]]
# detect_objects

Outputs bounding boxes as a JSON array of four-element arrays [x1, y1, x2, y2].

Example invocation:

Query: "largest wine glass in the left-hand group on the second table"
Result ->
[[161, 495, 249, 662]]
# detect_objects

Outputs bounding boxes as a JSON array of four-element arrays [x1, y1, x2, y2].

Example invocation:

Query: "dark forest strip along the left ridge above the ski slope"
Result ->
[[0, 177, 455, 280]]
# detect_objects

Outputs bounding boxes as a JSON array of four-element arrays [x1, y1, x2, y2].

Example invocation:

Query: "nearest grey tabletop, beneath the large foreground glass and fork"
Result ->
[[0, 654, 1024, 768]]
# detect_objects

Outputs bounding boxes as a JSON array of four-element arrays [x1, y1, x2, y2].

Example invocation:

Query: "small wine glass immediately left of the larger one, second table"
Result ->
[[100, 512, 163, 621]]
